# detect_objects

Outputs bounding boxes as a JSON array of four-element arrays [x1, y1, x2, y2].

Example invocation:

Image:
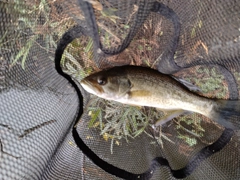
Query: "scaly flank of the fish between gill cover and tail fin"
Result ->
[[124, 67, 215, 116]]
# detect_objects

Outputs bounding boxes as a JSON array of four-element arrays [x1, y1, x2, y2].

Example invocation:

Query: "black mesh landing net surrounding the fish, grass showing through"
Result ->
[[0, 0, 240, 180]]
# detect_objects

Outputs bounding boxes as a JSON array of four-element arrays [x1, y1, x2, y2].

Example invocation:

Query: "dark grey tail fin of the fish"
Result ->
[[209, 100, 240, 130]]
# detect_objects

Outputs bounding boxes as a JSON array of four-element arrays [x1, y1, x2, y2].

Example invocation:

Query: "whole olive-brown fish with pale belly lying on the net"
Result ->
[[80, 65, 240, 129]]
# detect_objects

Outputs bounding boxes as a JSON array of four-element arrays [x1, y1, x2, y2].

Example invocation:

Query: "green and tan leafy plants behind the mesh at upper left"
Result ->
[[8, 0, 75, 69]]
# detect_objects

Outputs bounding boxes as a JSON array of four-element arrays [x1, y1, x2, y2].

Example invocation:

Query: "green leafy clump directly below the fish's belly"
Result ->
[[87, 95, 163, 152]]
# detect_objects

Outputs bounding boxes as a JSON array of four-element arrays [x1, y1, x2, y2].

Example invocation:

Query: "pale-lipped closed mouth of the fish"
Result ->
[[80, 79, 103, 95]]
